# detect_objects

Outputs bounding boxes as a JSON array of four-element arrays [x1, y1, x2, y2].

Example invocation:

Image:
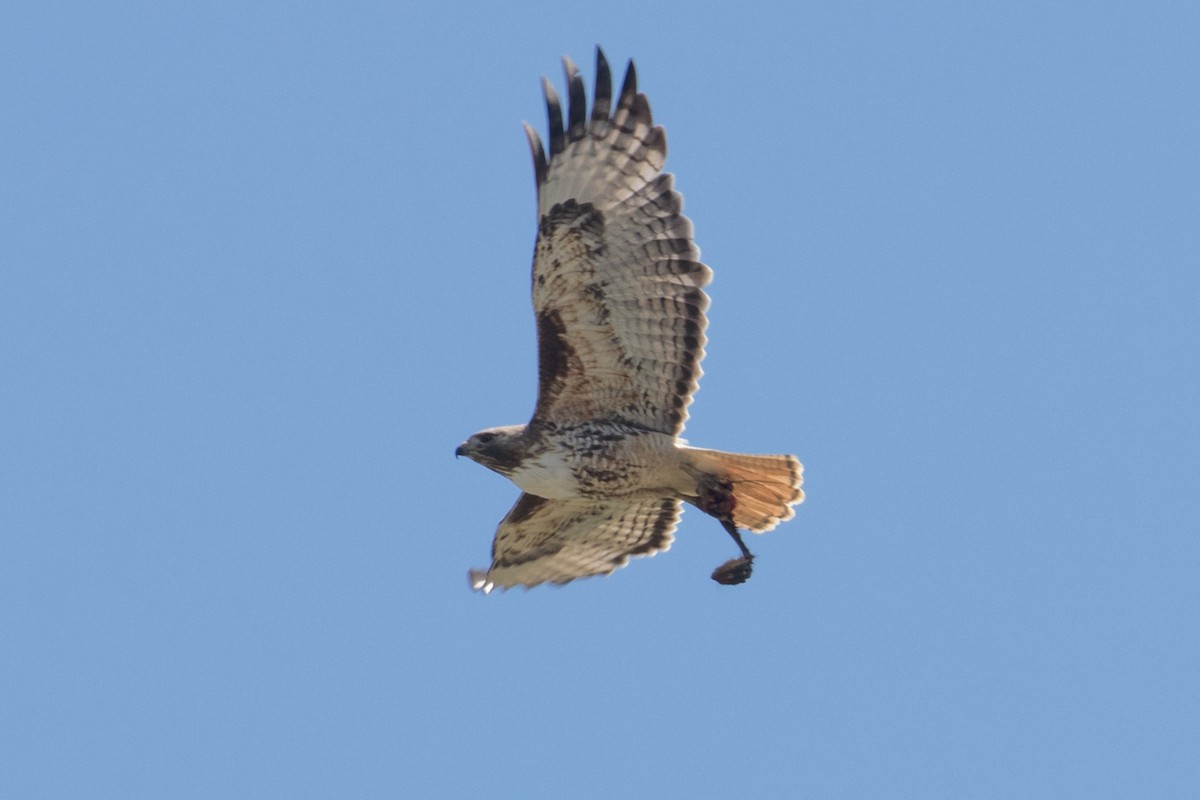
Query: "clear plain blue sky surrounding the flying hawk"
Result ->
[[0, 0, 1200, 799]]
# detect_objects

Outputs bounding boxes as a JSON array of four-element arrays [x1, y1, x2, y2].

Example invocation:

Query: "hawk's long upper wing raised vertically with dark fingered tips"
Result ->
[[526, 48, 712, 434]]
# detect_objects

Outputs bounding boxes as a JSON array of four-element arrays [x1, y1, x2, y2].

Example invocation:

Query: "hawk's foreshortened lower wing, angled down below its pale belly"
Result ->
[[469, 494, 679, 594]]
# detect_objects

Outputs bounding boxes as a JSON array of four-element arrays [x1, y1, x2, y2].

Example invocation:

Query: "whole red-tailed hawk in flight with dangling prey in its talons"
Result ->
[[456, 48, 804, 593]]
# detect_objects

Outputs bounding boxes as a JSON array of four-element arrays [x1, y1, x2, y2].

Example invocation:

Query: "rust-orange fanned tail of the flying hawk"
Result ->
[[684, 447, 804, 534]]
